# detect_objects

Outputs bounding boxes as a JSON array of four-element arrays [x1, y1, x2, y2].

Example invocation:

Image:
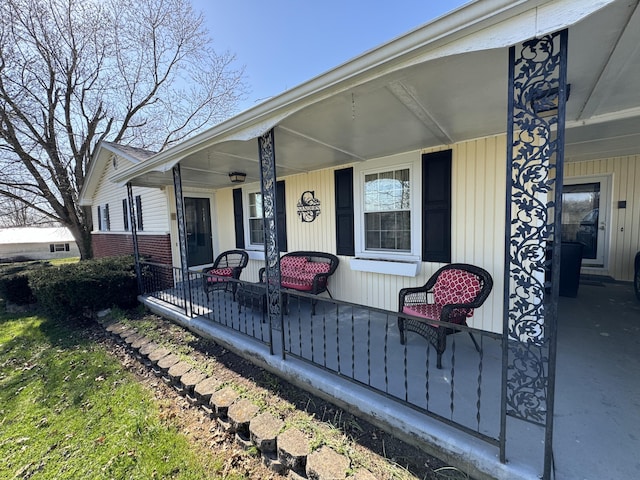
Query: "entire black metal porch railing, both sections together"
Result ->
[[144, 264, 502, 446]]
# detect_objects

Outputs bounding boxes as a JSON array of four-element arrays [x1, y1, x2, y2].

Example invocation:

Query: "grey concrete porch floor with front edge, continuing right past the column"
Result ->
[[141, 270, 640, 479]]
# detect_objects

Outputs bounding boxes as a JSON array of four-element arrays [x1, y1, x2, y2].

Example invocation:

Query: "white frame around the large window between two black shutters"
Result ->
[[353, 157, 422, 262]]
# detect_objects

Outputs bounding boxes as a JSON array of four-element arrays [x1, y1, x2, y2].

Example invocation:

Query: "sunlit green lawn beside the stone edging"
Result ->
[[0, 314, 242, 480]]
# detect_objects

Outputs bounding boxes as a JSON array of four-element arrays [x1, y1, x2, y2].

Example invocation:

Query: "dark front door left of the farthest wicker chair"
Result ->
[[184, 197, 213, 267]]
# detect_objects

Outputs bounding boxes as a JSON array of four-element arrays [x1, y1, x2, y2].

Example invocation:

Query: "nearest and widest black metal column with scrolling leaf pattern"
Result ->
[[500, 30, 568, 479]]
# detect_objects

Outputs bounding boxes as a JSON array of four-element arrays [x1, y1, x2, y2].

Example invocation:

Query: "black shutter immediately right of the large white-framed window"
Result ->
[[422, 150, 452, 263]]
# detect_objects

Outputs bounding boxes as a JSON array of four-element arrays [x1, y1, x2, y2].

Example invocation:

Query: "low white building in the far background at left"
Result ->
[[0, 227, 80, 262]]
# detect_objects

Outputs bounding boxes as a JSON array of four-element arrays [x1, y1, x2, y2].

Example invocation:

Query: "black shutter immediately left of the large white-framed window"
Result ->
[[334, 168, 356, 256]]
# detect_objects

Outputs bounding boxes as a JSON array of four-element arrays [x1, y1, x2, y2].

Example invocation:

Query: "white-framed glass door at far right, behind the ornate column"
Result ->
[[562, 177, 610, 267]]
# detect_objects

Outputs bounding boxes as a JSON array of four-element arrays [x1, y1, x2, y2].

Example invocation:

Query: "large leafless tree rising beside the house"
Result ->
[[0, 0, 245, 258]]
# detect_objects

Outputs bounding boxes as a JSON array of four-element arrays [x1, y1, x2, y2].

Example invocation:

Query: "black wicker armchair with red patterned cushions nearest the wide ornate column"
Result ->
[[398, 263, 493, 368]]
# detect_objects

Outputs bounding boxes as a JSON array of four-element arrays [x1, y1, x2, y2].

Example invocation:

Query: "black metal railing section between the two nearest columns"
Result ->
[[284, 293, 502, 446]]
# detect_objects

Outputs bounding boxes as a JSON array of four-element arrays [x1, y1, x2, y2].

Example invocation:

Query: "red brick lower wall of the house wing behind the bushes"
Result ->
[[91, 233, 171, 265]]
